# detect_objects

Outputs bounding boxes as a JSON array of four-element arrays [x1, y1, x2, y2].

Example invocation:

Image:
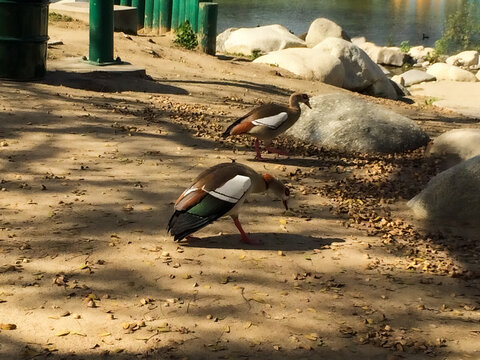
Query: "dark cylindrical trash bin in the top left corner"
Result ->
[[0, 0, 49, 80]]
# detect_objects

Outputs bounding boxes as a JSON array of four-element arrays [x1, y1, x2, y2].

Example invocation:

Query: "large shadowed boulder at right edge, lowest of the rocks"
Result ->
[[407, 155, 480, 226]]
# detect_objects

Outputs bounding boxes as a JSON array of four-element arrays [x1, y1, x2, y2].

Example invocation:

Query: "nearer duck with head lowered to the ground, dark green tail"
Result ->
[[167, 162, 290, 245]]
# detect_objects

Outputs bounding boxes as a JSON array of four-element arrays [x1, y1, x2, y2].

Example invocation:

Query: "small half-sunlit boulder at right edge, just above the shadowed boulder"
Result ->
[[427, 129, 480, 164]]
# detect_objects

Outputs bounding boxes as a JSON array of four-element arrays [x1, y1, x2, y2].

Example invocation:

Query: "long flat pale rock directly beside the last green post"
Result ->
[[217, 25, 305, 56]]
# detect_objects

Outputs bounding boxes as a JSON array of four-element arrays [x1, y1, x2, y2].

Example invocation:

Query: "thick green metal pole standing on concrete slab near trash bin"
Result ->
[[88, 0, 114, 65]]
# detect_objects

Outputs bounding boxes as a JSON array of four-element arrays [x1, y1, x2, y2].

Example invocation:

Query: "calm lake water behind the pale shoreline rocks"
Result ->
[[216, 0, 480, 46]]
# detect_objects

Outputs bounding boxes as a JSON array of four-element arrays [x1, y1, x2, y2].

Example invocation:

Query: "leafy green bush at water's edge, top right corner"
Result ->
[[435, 1, 480, 55]]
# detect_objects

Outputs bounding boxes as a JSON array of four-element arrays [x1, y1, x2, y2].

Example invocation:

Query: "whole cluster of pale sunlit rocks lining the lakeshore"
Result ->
[[217, 18, 480, 99]]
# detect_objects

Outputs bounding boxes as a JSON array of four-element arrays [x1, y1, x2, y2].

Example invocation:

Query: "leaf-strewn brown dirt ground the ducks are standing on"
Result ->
[[0, 18, 480, 360]]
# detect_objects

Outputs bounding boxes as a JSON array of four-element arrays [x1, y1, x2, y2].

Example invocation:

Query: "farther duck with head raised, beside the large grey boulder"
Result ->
[[222, 92, 312, 160]]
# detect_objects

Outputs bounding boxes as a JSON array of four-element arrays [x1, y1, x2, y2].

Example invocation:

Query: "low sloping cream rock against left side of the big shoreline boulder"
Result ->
[[253, 48, 345, 87]]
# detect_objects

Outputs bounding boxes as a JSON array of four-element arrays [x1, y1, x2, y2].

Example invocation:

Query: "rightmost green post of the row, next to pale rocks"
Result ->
[[198, 2, 218, 55]]
